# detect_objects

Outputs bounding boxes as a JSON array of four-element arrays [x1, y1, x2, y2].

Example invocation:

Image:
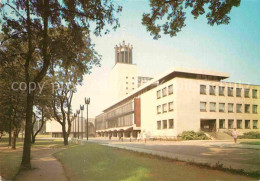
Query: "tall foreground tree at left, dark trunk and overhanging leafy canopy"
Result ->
[[1, 0, 121, 168]]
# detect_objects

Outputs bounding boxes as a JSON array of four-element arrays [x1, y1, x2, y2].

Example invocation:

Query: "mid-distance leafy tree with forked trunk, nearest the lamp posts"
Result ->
[[50, 28, 100, 145]]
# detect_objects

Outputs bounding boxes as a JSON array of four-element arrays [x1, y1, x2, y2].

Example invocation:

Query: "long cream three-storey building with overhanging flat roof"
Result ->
[[95, 41, 260, 138]]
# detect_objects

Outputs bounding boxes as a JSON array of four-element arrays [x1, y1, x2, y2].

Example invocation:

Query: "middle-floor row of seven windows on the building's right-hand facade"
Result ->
[[200, 102, 257, 114]]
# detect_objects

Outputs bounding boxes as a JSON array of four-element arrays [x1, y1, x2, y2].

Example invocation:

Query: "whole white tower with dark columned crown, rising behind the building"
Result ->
[[110, 41, 138, 100]]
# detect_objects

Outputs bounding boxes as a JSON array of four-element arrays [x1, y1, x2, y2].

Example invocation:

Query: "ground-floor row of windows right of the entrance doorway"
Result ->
[[219, 119, 258, 129]]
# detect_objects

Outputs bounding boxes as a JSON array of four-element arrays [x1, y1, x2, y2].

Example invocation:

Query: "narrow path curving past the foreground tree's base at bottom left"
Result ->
[[15, 146, 67, 181]]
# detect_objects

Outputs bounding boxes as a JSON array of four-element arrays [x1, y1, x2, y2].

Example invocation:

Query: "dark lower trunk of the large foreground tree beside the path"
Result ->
[[21, 92, 34, 169]]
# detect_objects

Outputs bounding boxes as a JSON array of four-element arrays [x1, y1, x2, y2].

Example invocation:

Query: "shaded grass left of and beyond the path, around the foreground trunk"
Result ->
[[0, 138, 63, 180]]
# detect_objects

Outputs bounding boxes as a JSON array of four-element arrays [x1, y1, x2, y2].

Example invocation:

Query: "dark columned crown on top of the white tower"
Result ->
[[115, 41, 133, 64]]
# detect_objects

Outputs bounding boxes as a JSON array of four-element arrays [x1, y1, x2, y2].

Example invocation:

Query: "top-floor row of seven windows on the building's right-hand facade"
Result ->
[[200, 85, 257, 98]]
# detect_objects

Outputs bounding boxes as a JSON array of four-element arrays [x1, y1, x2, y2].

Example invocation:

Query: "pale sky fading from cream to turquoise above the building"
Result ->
[[72, 0, 260, 117]]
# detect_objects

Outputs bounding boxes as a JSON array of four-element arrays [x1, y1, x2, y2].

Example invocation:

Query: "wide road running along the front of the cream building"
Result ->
[[89, 138, 260, 173]]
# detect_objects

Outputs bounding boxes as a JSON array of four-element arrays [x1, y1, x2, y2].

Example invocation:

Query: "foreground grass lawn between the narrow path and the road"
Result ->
[[54, 143, 252, 181]]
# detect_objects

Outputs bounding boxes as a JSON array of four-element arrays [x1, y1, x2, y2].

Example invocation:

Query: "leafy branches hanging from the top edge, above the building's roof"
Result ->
[[142, 0, 241, 39]]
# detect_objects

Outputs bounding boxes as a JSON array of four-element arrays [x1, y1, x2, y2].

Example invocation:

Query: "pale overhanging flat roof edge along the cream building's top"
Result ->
[[103, 67, 230, 112]]
